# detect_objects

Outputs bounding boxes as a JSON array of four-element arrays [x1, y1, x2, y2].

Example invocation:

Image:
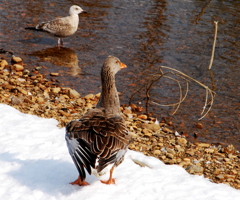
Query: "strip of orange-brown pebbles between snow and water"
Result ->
[[0, 57, 240, 189]]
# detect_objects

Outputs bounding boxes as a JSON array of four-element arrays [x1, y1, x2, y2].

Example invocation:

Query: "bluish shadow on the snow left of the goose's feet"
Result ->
[[0, 153, 97, 195]]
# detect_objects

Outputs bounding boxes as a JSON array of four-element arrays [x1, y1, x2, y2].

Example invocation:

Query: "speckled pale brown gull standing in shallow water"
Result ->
[[25, 5, 86, 46]]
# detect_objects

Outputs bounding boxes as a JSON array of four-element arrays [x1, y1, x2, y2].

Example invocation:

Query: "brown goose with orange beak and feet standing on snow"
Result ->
[[65, 56, 131, 186]]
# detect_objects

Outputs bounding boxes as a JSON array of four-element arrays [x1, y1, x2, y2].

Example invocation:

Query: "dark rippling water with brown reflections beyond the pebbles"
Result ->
[[0, 0, 240, 149]]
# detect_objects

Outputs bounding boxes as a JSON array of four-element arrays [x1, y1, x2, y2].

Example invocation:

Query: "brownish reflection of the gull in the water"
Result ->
[[29, 47, 81, 76]]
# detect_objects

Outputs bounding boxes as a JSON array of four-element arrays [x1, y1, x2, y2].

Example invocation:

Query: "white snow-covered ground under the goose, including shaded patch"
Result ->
[[0, 104, 240, 200]]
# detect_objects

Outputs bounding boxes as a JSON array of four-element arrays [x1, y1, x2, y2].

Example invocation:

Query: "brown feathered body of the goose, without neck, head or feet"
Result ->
[[66, 111, 130, 178]]
